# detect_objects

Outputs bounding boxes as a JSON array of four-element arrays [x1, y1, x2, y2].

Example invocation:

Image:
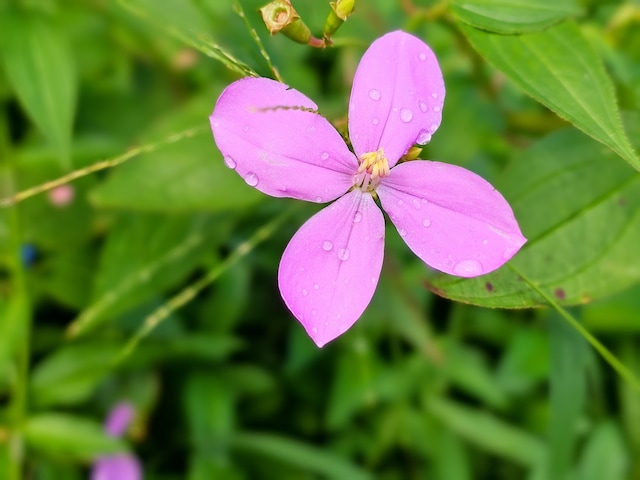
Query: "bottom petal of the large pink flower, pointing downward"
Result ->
[[278, 190, 384, 347]]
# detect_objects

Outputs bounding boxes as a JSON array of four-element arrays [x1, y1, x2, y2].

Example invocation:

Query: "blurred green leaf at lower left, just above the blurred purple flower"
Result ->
[[24, 413, 126, 461]]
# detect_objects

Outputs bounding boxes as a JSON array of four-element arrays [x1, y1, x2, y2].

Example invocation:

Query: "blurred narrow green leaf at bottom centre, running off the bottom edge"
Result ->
[[232, 432, 373, 480]]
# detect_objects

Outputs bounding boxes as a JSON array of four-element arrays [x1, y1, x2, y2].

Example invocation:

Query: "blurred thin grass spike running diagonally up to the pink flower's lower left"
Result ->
[[113, 207, 295, 364]]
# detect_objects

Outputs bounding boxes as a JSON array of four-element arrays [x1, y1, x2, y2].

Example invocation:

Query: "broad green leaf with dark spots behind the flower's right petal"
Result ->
[[432, 119, 640, 308]]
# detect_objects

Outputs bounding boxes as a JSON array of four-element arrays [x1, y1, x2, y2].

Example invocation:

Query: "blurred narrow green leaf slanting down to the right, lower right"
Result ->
[[427, 397, 546, 467]]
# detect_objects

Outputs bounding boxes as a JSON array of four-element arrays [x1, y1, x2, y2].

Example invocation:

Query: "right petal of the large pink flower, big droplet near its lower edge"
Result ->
[[377, 160, 527, 277]]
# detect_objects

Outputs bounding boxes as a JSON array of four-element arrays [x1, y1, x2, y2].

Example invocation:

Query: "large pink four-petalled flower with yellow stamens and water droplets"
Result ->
[[210, 31, 526, 347]]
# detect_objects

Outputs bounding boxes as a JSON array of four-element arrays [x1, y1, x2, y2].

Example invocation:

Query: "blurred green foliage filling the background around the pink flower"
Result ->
[[0, 0, 640, 480]]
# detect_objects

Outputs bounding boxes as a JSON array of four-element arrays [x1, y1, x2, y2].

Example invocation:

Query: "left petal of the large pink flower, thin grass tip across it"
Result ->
[[209, 78, 357, 203]]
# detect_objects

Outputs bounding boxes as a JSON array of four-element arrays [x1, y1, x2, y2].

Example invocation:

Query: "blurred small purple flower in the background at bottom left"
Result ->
[[91, 403, 142, 480]]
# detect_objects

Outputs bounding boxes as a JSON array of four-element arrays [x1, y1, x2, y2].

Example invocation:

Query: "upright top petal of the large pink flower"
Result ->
[[349, 31, 445, 167]]
